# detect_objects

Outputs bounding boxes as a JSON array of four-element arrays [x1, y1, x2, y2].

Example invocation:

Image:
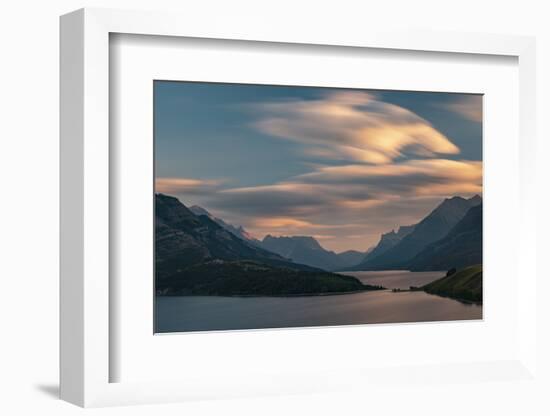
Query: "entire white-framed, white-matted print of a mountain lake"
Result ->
[[61, 9, 538, 406]]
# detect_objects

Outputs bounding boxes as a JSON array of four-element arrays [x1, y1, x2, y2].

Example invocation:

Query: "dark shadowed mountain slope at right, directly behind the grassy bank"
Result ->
[[408, 204, 483, 271]]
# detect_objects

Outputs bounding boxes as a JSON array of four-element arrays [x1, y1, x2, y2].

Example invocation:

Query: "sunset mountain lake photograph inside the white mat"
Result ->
[[152, 80, 483, 333]]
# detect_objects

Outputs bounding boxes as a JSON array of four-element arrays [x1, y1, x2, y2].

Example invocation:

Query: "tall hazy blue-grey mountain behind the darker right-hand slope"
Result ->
[[354, 195, 481, 270]]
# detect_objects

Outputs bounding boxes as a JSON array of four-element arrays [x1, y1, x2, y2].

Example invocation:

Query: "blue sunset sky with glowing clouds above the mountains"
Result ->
[[154, 81, 482, 252]]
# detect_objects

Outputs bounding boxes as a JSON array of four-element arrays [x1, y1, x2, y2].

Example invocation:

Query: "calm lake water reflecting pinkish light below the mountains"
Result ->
[[156, 271, 482, 332]]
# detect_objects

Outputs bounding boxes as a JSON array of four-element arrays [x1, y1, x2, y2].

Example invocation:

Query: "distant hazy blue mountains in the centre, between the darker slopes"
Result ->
[[260, 235, 365, 271]]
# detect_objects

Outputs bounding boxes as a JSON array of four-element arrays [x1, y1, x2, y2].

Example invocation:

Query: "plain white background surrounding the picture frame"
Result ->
[[0, 0, 550, 415]]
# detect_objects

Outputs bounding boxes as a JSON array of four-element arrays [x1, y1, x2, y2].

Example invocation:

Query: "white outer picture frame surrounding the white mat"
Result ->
[[60, 9, 537, 407]]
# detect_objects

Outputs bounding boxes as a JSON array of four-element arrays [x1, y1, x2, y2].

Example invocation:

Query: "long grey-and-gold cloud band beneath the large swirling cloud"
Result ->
[[205, 159, 482, 222]]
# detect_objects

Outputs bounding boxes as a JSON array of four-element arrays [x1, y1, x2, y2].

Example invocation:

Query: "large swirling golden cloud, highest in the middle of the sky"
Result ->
[[254, 92, 460, 164]]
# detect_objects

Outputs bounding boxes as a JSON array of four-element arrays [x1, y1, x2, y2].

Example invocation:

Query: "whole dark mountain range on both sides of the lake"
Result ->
[[155, 194, 482, 295]]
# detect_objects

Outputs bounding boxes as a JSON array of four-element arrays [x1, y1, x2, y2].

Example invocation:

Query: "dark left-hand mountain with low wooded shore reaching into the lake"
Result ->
[[155, 194, 380, 296]]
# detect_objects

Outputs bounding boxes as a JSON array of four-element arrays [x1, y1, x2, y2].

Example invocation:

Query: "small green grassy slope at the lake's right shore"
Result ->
[[422, 265, 483, 303]]
